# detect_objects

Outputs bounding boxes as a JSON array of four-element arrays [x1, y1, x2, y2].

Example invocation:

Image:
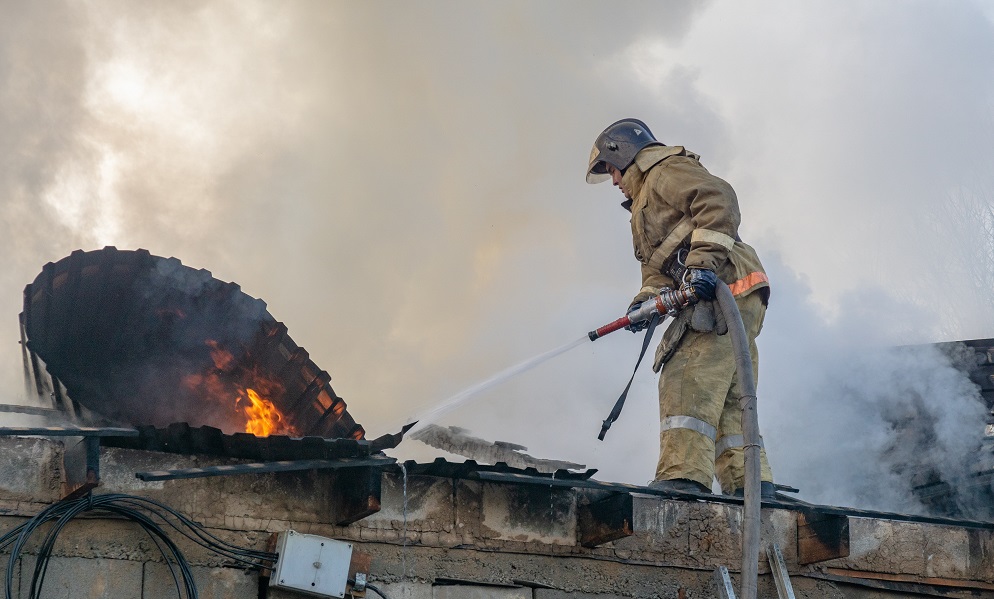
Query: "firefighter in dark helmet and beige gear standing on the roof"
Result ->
[[587, 119, 775, 499]]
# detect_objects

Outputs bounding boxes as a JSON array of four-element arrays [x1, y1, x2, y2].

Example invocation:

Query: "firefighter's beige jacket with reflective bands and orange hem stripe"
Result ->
[[622, 146, 769, 303]]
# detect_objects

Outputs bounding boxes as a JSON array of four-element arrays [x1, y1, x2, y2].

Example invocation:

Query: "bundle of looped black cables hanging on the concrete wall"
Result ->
[[0, 493, 277, 599]]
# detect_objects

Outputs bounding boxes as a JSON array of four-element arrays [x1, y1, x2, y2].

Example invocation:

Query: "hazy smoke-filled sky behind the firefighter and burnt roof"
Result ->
[[0, 0, 994, 507]]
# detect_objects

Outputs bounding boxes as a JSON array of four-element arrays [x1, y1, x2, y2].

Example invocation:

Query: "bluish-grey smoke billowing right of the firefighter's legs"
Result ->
[[759, 256, 990, 518]]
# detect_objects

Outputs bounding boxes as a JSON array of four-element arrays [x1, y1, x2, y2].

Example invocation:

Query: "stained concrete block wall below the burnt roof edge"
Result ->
[[0, 438, 994, 599]]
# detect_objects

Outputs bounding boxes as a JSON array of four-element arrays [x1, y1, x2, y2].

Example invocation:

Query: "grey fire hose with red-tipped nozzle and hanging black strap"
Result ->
[[587, 280, 761, 599]]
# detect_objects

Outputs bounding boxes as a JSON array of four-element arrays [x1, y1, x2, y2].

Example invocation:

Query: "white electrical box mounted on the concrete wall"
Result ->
[[269, 530, 352, 597]]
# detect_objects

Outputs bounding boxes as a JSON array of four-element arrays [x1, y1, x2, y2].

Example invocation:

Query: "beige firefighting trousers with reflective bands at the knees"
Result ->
[[656, 293, 773, 494]]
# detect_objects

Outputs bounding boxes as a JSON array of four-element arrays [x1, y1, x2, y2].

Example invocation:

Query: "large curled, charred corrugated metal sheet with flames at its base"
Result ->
[[22, 247, 365, 439]]
